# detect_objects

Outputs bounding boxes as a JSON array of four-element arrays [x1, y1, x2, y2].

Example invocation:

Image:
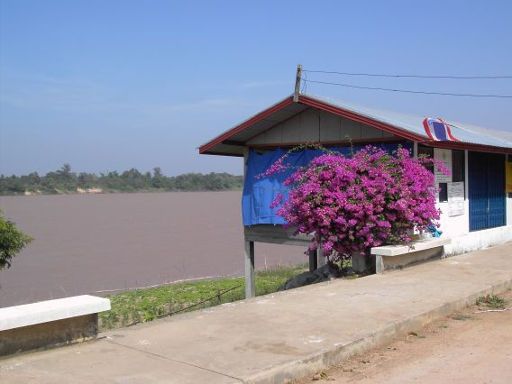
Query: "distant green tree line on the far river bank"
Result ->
[[0, 164, 243, 195]]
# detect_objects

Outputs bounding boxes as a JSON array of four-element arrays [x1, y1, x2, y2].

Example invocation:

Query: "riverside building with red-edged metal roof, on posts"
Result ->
[[199, 95, 512, 297]]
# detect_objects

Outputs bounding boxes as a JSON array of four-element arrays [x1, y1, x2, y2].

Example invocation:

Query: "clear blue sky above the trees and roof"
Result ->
[[0, 0, 512, 175]]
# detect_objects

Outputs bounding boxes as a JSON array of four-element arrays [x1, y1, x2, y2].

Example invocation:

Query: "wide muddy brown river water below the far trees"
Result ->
[[0, 191, 306, 307]]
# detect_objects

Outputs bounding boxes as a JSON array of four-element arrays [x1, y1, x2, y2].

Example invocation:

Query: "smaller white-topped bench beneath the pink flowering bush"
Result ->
[[370, 237, 451, 273]]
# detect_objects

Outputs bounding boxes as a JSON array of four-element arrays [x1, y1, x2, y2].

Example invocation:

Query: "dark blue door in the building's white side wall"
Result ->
[[468, 152, 505, 231]]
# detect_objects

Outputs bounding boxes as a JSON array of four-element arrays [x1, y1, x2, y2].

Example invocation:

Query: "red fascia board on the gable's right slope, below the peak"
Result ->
[[299, 96, 425, 141]]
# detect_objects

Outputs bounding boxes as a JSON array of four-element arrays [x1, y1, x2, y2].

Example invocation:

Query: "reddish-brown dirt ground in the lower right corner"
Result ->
[[294, 290, 512, 384]]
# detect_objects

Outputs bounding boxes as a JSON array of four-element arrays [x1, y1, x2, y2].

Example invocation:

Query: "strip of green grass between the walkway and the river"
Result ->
[[99, 265, 306, 330]]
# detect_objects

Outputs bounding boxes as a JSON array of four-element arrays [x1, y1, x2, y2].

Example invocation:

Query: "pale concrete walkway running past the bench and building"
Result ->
[[0, 243, 512, 384]]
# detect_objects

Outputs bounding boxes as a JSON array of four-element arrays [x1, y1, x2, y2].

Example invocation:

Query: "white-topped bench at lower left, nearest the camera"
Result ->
[[0, 295, 110, 356]]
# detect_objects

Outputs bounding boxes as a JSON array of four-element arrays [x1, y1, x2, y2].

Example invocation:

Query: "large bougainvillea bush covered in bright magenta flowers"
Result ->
[[271, 146, 445, 261]]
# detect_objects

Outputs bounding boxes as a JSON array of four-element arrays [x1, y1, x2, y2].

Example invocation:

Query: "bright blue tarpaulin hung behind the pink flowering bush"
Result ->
[[242, 143, 412, 226]]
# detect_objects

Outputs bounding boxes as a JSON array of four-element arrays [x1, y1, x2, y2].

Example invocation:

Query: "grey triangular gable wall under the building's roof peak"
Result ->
[[248, 109, 393, 145]]
